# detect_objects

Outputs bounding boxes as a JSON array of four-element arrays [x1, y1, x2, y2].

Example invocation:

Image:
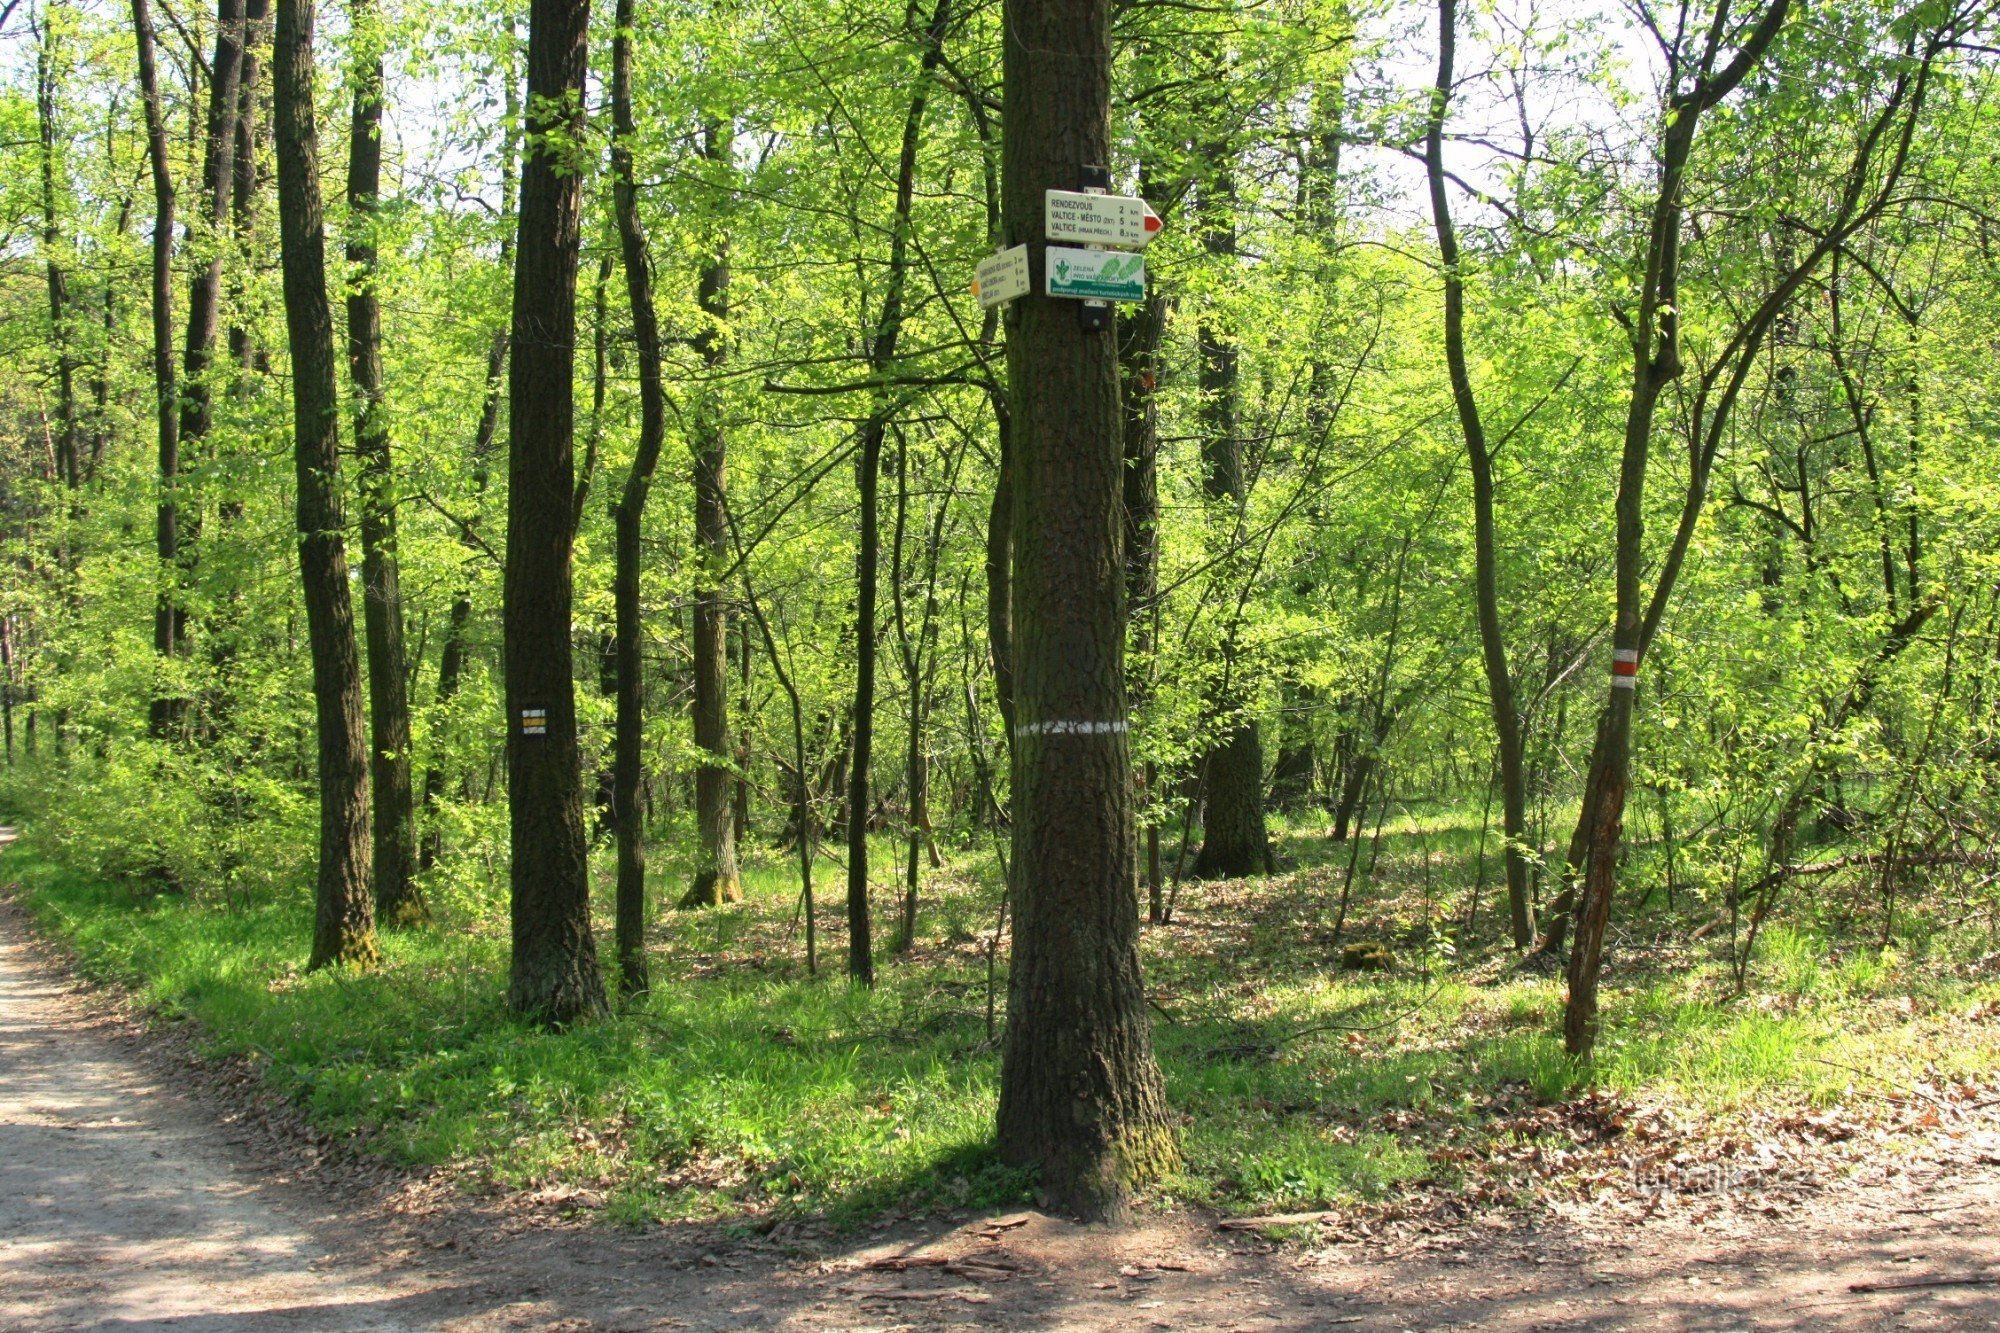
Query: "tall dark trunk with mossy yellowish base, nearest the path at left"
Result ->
[[272, 0, 376, 967]]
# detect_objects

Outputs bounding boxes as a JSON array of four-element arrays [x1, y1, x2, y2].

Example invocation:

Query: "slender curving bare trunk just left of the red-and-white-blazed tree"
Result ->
[[1424, 0, 1534, 949]]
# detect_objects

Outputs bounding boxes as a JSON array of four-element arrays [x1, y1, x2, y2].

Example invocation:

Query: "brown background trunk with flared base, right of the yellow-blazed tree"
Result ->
[[680, 122, 742, 907]]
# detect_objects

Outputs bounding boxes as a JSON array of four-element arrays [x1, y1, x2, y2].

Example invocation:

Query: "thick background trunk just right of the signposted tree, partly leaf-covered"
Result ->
[[1194, 150, 1272, 879]]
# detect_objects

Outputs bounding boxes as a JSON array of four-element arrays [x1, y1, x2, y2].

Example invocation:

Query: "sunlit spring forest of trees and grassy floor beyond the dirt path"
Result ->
[[0, 0, 2000, 1223]]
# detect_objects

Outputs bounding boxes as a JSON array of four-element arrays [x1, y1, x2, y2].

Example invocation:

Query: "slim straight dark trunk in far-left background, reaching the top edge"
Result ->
[[132, 0, 184, 739]]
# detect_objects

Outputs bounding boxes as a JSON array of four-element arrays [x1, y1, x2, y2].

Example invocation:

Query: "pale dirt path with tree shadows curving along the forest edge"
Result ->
[[0, 836, 2000, 1331]]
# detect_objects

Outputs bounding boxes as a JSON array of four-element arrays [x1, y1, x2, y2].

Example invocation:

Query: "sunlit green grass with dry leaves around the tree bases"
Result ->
[[6, 792, 2000, 1223]]
